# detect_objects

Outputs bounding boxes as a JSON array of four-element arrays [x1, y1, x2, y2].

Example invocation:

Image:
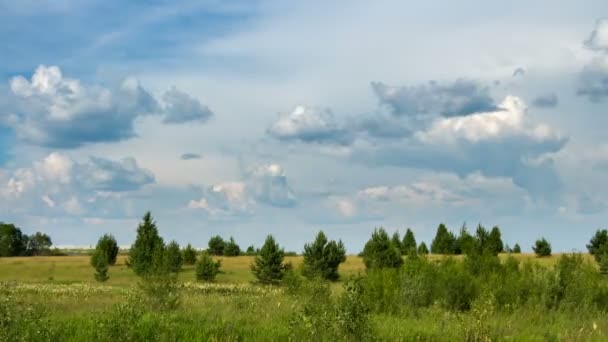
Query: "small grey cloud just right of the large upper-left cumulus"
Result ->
[[163, 87, 213, 124]]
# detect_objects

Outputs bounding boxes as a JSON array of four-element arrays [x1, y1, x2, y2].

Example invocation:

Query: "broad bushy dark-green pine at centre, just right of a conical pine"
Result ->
[[302, 231, 346, 281]]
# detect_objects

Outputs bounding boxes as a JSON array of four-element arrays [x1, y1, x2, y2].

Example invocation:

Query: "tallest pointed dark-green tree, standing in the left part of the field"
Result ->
[[129, 212, 164, 276]]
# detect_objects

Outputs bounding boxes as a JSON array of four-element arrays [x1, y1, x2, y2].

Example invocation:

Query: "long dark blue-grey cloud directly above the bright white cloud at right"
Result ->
[[372, 79, 496, 117]]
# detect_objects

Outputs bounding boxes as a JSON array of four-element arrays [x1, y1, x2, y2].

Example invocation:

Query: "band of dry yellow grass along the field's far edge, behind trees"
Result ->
[[0, 254, 593, 286]]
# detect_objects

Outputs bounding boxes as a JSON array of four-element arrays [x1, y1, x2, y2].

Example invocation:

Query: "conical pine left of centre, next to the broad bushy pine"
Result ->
[[251, 235, 291, 284]]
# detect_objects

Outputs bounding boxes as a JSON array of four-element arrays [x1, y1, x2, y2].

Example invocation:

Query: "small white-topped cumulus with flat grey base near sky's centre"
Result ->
[[266, 106, 352, 144]]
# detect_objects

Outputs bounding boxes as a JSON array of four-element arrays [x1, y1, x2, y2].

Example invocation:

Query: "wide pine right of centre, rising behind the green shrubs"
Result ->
[[363, 228, 403, 269]]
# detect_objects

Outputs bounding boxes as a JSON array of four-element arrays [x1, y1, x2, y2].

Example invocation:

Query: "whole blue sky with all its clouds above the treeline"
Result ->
[[0, 0, 608, 253]]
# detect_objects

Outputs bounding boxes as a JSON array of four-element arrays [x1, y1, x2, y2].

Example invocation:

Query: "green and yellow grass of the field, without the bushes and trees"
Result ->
[[0, 254, 608, 342]]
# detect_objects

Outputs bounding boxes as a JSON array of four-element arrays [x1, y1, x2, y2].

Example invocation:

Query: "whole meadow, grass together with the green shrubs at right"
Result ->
[[0, 254, 608, 341]]
